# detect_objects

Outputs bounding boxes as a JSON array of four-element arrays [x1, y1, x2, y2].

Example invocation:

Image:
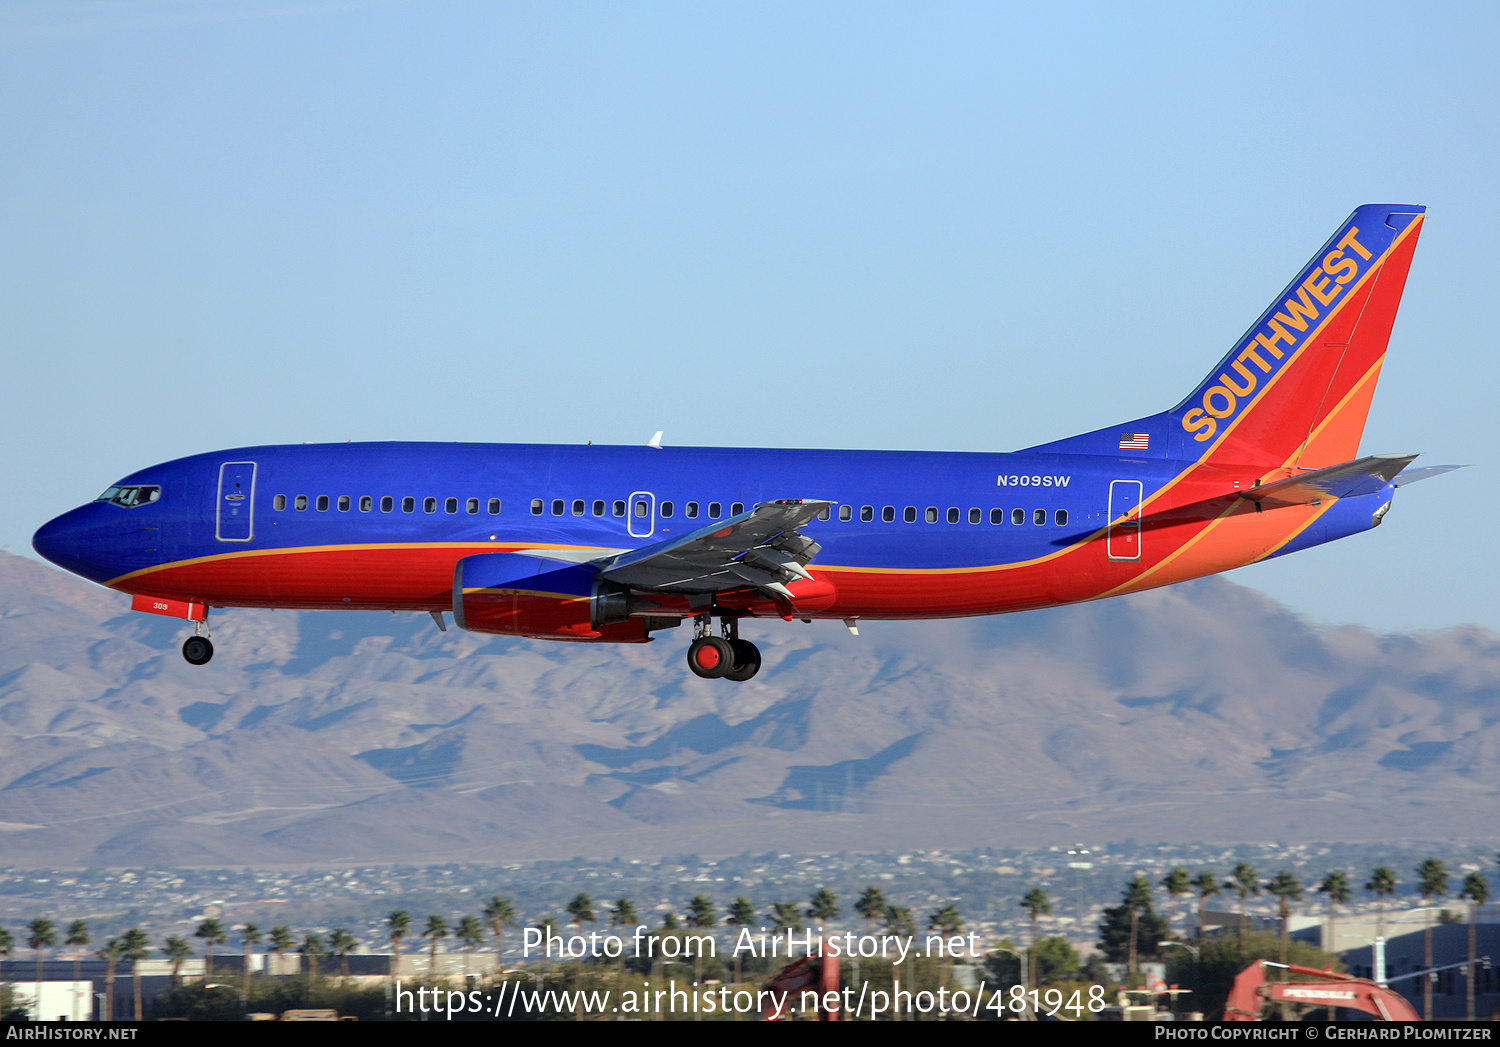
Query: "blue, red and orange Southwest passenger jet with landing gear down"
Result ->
[[33, 204, 1458, 681]]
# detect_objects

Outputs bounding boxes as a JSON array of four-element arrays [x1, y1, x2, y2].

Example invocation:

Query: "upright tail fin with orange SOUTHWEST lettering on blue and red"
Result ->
[[1029, 204, 1427, 470]]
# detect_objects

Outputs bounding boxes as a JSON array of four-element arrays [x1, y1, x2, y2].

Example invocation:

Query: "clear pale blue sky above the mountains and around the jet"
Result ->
[[0, 0, 1500, 629]]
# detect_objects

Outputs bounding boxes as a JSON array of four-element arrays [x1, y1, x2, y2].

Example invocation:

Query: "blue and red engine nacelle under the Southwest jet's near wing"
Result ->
[[453, 552, 654, 644]]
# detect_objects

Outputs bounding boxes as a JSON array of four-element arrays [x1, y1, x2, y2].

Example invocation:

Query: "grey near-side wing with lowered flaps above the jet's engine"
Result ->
[[600, 498, 834, 600]]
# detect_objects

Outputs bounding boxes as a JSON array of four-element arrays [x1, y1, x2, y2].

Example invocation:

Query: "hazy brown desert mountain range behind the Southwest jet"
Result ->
[[0, 554, 1500, 867]]
